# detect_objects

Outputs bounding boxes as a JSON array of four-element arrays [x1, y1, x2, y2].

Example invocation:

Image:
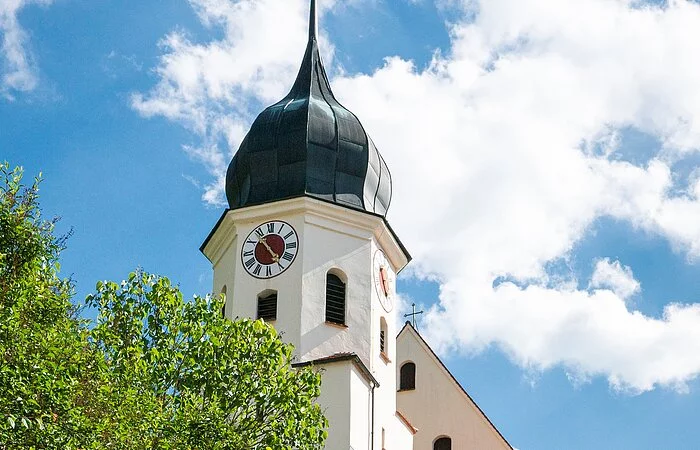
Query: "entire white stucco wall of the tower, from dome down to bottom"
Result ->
[[204, 198, 411, 450]]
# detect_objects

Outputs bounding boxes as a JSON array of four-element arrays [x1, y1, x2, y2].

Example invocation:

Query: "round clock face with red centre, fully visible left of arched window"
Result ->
[[241, 220, 299, 279]]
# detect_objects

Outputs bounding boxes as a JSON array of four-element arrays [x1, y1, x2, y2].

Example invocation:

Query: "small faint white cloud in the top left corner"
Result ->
[[0, 0, 53, 98]]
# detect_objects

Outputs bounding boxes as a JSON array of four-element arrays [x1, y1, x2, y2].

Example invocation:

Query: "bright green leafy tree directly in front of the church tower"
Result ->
[[88, 271, 327, 450]]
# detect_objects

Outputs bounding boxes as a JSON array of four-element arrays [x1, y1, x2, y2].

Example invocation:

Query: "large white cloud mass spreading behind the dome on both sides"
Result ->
[[134, 0, 700, 392]]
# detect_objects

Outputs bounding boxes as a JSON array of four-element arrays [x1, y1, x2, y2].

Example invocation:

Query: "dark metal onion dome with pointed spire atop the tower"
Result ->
[[226, 0, 391, 216]]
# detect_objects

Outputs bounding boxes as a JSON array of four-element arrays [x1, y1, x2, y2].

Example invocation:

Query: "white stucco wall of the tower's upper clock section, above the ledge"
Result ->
[[204, 198, 406, 370]]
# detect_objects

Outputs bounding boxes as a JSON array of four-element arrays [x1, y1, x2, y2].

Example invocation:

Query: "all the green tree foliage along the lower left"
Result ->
[[0, 164, 327, 450]]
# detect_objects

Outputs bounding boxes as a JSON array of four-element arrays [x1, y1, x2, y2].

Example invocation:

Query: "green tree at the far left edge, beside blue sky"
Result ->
[[0, 163, 100, 449]]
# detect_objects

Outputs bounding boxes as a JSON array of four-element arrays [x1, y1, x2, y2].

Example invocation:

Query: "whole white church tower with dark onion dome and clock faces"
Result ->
[[201, 0, 413, 450]]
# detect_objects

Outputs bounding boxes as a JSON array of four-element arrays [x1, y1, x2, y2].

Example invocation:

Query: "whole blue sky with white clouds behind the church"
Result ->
[[0, 0, 700, 449]]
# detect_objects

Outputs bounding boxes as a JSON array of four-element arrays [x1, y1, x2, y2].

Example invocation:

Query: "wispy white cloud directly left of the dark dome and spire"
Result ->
[[131, 0, 340, 205]]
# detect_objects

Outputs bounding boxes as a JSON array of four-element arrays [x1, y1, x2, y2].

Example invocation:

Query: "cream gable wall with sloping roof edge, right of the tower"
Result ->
[[396, 327, 511, 450]]
